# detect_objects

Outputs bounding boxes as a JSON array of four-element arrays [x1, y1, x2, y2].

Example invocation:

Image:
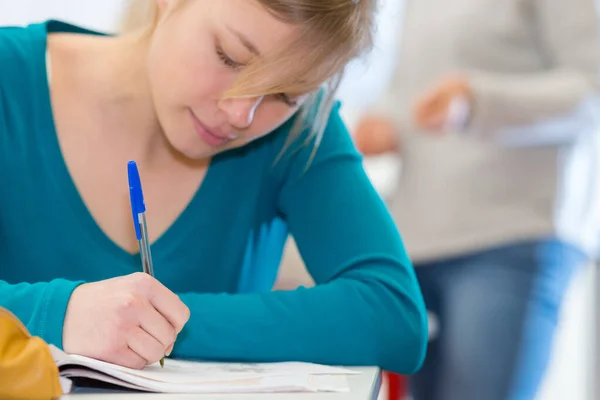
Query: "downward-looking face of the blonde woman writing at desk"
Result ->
[[148, 0, 305, 159]]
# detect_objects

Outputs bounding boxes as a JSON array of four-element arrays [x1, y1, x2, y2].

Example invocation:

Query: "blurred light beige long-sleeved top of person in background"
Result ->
[[375, 0, 600, 261]]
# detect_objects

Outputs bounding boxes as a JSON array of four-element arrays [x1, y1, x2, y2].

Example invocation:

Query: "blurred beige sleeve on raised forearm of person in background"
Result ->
[[469, 0, 600, 140]]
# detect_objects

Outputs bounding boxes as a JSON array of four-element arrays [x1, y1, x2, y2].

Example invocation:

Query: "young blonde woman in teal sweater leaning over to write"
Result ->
[[0, 0, 427, 373]]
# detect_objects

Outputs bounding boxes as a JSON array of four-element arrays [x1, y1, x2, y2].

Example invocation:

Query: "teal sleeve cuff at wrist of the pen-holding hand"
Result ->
[[0, 279, 79, 349]]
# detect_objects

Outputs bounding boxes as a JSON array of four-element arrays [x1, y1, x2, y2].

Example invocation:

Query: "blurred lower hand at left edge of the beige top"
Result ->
[[353, 115, 400, 156]]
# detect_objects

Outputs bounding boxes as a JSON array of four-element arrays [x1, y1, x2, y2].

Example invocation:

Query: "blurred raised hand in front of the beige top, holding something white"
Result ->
[[413, 76, 473, 132]]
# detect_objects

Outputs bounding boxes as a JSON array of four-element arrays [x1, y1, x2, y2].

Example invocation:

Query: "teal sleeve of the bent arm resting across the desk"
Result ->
[[174, 106, 428, 374]]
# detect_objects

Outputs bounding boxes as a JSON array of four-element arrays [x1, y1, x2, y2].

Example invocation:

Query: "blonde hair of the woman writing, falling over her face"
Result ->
[[121, 0, 377, 162]]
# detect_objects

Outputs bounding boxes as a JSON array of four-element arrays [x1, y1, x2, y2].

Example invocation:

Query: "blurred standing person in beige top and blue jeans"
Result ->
[[354, 0, 600, 400]]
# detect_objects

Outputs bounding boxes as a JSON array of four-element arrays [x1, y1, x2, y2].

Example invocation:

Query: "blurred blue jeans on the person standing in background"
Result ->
[[411, 239, 587, 400]]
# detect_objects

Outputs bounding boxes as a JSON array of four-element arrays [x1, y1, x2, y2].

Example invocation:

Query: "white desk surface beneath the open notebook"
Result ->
[[60, 367, 381, 400]]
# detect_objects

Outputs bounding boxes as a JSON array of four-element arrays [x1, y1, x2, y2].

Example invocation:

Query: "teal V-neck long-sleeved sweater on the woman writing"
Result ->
[[0, 21, 427, 373]]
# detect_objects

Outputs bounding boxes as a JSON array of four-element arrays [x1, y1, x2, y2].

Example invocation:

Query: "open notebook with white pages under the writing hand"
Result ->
[[50, 346, 357, 393]]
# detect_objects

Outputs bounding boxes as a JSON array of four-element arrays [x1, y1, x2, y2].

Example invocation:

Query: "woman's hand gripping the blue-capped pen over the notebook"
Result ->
[[63, 273, 190, 369]]
